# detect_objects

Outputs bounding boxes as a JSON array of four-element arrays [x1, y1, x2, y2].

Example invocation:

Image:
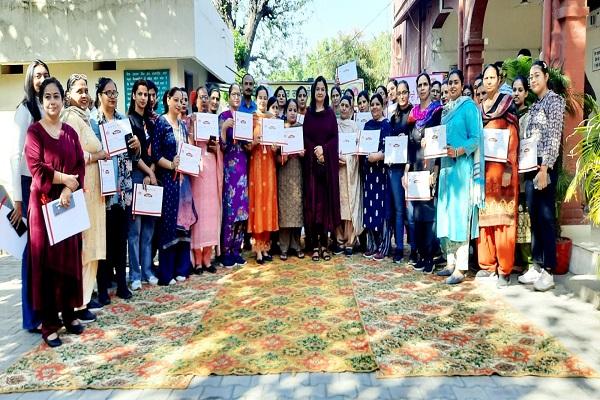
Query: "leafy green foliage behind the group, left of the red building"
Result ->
[[269, 32, 391, 91]]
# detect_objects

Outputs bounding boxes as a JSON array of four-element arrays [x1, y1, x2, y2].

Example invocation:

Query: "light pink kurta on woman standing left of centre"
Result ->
[[191, 141, 223, 249]]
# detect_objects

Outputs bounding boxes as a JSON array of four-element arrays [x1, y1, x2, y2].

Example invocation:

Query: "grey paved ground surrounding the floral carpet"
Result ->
[[0, 256, 600, 400]]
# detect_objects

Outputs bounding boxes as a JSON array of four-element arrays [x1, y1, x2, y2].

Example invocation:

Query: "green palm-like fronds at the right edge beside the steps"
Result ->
[[566, 115, 600, 225]]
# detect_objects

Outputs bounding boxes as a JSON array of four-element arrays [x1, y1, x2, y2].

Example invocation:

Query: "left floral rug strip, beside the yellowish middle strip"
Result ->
[[0, 273, 223, 393]]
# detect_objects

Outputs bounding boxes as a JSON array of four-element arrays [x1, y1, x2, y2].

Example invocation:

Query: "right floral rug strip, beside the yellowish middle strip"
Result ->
[[349, 260, 597, 378]]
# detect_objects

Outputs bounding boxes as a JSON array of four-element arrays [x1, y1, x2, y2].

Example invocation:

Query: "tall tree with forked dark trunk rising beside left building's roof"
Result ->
[[213, 0, 310, 71]]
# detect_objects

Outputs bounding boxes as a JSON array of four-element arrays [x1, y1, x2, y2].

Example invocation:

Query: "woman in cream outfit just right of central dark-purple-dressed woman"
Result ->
[[334, 96, 363, 257]]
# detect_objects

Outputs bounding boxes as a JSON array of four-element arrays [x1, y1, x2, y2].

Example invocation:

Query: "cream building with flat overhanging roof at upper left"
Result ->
[[0, 0, 236, 194]]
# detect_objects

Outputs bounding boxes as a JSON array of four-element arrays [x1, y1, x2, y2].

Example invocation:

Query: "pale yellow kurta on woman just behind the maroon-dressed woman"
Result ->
[[61, 106, 106, 265]]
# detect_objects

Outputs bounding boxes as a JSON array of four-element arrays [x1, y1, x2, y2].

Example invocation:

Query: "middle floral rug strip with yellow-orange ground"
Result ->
[[174, 258, 377, 375]]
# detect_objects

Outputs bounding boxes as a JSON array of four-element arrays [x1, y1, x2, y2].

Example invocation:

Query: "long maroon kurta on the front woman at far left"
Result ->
[[25, 122, 85, 310]]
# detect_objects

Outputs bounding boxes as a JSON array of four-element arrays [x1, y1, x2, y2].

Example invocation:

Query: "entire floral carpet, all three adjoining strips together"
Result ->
[[0, 256, 598, 393]]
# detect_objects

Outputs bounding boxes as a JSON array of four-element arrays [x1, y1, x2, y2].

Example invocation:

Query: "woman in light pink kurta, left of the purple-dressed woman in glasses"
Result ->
[[190, 86, 223, 274]]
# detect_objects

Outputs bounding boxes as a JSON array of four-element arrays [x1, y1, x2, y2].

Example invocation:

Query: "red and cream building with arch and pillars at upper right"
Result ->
[[390, 0, 600, 224]]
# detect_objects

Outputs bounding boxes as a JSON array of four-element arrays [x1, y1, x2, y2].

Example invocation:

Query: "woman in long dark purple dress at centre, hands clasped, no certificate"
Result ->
[[303, 76, 341, 261]]
